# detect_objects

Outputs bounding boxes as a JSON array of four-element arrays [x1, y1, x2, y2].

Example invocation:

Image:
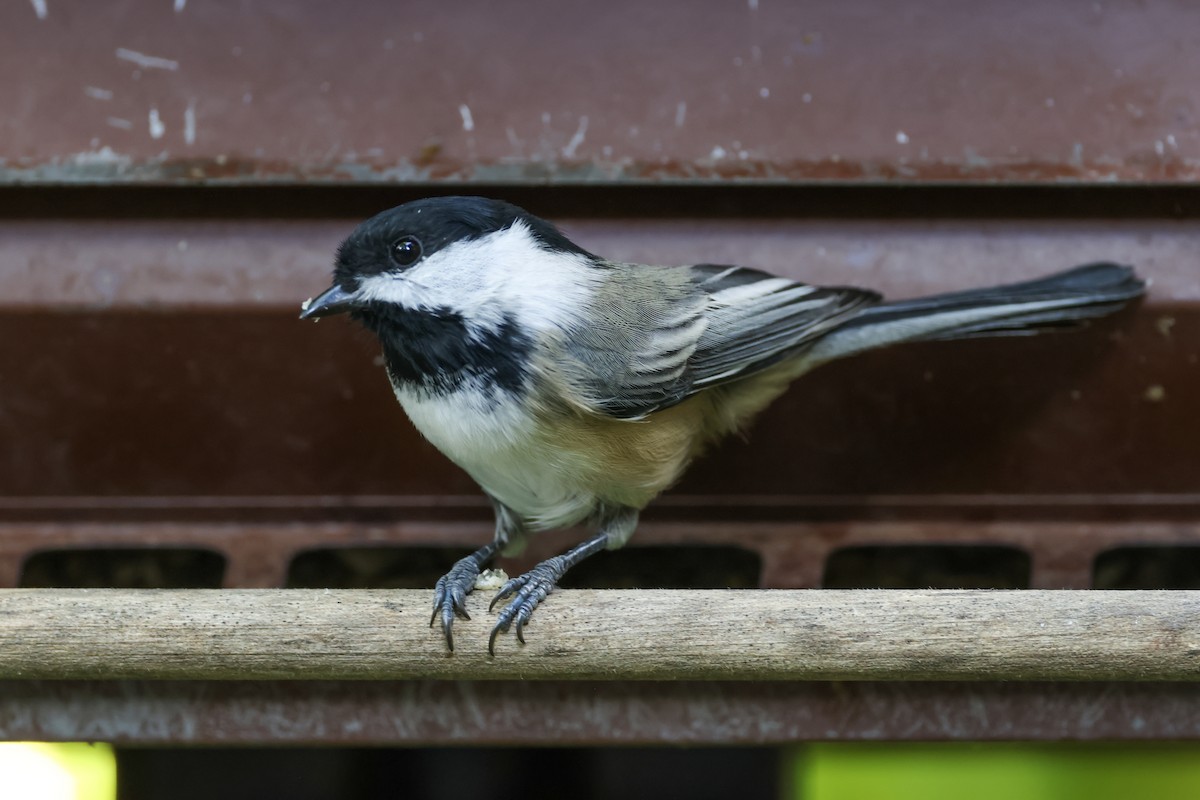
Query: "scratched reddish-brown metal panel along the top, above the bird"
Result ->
[[0, 0, 1200, 184]]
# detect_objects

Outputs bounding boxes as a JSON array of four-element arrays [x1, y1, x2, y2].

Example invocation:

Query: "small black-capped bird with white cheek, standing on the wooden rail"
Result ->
[[300, 197, 1145, 655]]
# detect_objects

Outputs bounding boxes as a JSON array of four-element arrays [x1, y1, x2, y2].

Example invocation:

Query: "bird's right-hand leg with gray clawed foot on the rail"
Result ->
[[487, 509, 637, 656]]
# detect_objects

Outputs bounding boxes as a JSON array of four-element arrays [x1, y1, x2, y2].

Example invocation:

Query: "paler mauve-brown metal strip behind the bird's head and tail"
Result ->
[[0, 215, 1200, 307]]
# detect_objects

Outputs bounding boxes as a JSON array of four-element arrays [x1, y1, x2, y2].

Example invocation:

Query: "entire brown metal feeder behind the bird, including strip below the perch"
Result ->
[[0, 0, 1200, 744]]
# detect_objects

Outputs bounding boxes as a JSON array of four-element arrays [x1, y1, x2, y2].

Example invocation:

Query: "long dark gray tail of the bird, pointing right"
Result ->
[[806, 263, 1146, 362]]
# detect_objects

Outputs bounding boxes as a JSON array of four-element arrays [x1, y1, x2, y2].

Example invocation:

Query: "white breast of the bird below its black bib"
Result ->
[[392, 383, 596, 530]]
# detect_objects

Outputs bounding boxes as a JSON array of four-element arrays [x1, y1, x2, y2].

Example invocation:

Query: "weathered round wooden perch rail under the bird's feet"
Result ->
[[0, 589, 1200, 680]]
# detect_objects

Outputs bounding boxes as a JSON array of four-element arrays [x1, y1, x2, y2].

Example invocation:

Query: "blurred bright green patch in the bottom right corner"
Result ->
[[788, 742, 1200, 800]]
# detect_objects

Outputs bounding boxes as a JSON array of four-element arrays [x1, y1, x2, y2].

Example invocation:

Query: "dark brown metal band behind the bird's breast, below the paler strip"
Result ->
[[0, 304, 1200, 501]]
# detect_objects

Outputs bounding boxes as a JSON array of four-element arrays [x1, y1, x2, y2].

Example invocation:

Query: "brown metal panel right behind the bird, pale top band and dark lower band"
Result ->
[[0, 219, 1200, 506]]
